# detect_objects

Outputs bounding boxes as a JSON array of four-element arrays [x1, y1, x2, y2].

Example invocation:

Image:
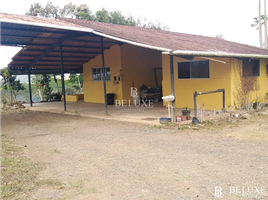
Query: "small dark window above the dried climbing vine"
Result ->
[[243, 59, 260, 76]]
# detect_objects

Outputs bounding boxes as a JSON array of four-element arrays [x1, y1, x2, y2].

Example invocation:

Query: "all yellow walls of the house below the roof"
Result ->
[[83, 44, 268, 110]]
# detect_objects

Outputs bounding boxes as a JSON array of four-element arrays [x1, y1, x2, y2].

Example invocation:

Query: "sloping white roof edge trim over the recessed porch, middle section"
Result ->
[[93, 31, 172, 52]]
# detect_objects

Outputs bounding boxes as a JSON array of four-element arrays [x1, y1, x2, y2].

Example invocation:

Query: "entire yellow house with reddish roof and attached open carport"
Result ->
[[0, 13, 268, 117]]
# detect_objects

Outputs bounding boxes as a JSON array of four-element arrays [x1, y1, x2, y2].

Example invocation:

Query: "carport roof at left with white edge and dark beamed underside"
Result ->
[[0, 14, 118, 74]]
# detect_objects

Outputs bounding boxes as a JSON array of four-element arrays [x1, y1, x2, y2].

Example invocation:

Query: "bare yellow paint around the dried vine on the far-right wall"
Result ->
[[231, 59, 268, 106]]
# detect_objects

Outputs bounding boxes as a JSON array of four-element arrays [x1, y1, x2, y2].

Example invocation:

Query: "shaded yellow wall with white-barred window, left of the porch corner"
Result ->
[[83, 45, 122, 103]]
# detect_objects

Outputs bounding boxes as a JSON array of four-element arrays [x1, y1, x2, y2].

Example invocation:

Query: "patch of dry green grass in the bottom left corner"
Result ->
[[0, 135, 42, 200]]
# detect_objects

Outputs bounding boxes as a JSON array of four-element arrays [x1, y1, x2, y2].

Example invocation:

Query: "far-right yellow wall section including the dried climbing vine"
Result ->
[[231, 59, 268, 107]]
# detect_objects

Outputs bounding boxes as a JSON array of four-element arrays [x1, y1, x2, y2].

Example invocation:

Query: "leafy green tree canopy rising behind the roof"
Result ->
[[25, 1, 169, 30]]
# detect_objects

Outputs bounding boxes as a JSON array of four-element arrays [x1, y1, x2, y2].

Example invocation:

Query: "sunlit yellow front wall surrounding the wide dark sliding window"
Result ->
[[162, 55, 231, 110]]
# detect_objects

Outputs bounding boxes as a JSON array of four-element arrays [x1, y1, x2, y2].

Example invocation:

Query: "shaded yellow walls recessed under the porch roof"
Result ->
[[83, 44, 162, 103]]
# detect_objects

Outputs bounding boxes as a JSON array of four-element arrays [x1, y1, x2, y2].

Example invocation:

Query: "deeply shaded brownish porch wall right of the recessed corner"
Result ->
[[121, 44, 162, 100]]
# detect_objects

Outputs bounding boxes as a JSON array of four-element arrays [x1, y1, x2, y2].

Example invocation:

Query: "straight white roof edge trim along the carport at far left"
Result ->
[[0, 18, 93, 33]]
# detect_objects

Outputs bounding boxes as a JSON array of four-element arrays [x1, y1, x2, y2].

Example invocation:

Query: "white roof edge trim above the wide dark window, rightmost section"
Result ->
[[169, 50, 268, 59]]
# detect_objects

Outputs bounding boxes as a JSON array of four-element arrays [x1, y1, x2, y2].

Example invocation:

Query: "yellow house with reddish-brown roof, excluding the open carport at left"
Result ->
[[59, 19, 268, 110]]
